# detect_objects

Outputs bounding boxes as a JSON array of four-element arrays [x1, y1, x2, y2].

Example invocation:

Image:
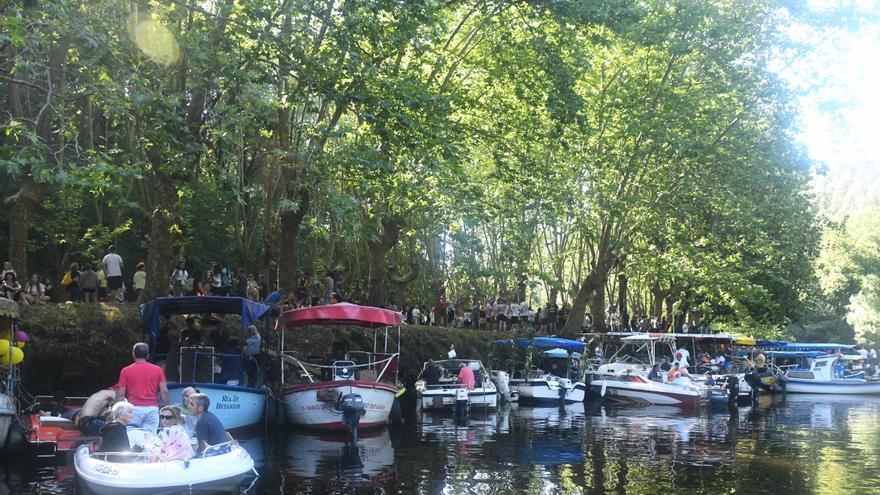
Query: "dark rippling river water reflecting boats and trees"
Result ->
[[0, 394, 880, 495]]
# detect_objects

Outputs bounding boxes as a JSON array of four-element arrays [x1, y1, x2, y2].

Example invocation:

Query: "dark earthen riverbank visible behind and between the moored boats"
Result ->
[[19, 304, 509, 396]]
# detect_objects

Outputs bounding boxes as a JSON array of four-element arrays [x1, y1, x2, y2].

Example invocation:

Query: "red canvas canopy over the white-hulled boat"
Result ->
[[278, 303, 403, 329]]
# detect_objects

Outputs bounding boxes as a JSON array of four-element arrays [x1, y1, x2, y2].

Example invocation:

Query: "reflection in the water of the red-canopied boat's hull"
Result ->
[[285, 429, 394, 482]]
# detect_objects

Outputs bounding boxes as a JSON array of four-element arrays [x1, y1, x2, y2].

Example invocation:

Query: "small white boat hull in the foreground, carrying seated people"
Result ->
[[74, 441, 255, 495]]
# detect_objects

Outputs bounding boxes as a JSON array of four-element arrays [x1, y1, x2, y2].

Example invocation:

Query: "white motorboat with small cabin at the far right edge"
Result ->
[[782, 354, 880, 395]]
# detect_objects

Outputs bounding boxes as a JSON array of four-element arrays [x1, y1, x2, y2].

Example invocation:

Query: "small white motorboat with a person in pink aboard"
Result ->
[[416, 359, 498, 411]]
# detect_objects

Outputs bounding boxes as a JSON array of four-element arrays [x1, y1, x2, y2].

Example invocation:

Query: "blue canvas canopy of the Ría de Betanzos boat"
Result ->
[[141, 296, 269, 347]]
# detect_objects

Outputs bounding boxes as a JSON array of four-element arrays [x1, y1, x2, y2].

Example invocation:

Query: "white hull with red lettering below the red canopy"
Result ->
[[282, 380, 397, 430]]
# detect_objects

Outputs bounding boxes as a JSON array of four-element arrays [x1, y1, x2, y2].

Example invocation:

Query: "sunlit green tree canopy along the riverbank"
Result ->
[[0, 0, 828, 333]]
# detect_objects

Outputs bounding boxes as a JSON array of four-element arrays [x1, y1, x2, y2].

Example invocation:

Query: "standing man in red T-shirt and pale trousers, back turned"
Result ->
[[116, 342, 170, 433]]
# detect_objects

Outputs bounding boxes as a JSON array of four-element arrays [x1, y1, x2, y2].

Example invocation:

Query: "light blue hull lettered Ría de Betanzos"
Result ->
[[168, 383, 269, 430]]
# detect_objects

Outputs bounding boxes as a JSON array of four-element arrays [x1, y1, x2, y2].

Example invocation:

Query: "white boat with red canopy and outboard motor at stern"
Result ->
[[277, 303, 403, 430]]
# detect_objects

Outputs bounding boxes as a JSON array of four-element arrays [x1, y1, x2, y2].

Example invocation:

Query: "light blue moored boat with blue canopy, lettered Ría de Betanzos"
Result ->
[[141, 297, 269, 430]]
